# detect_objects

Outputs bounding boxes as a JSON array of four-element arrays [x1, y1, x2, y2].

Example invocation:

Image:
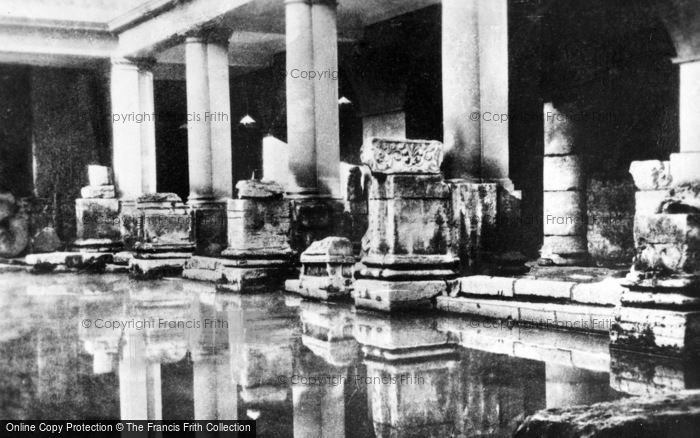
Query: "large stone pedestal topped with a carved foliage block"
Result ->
[[353, 138, 458, 311]]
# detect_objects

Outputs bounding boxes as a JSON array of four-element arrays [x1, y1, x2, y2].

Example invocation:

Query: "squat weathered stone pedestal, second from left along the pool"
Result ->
[[125, 193, 194, 277]]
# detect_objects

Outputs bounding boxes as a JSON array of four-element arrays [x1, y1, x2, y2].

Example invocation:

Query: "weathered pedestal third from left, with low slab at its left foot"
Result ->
[[183, 180, 292, 292]]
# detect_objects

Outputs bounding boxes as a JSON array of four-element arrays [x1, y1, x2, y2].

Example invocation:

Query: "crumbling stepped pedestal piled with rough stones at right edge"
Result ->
[[611, 161, 700, 354]]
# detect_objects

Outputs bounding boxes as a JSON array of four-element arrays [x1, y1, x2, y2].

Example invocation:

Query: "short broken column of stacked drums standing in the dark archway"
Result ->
[[540, 102, 588, 265]]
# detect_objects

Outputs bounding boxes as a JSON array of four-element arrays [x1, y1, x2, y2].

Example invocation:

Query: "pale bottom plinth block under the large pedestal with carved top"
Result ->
[[353, 279, 448, 312]]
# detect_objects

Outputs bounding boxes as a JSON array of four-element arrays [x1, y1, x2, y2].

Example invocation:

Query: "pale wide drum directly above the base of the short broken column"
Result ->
[[542, 191, 587, 236]]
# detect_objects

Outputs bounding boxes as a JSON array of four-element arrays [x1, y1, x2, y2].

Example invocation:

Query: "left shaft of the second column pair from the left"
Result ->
[[185, 37, 214, 201]]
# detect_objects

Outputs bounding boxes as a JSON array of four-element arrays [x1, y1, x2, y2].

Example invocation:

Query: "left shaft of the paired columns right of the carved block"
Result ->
[[442, 0, 482, 179]]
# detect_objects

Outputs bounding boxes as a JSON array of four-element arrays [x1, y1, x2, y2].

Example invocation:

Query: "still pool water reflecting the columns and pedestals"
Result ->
[[0, 274, 699, 438]]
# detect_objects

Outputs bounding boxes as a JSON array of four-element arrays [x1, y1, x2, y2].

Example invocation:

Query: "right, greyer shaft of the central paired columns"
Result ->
[[311, 0, 342, 198]]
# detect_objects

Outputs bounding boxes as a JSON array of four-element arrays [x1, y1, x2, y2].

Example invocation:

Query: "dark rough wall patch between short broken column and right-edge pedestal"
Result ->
[[586, 179, 641, 265]]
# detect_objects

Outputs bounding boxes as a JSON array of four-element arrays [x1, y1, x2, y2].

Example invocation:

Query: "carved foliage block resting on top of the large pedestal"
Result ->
[[360, 137, 443, 174]]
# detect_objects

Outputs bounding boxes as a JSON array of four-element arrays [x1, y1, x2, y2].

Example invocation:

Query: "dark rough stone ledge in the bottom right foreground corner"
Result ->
[[514, 390, 700, 438]]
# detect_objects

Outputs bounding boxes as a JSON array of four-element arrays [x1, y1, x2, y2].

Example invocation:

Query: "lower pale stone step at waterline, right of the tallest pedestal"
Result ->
[[437, 296, 615, 332]]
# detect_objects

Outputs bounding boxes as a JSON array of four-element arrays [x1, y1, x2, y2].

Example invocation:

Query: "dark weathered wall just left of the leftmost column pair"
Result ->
[[30, 68, 110, 246]]
